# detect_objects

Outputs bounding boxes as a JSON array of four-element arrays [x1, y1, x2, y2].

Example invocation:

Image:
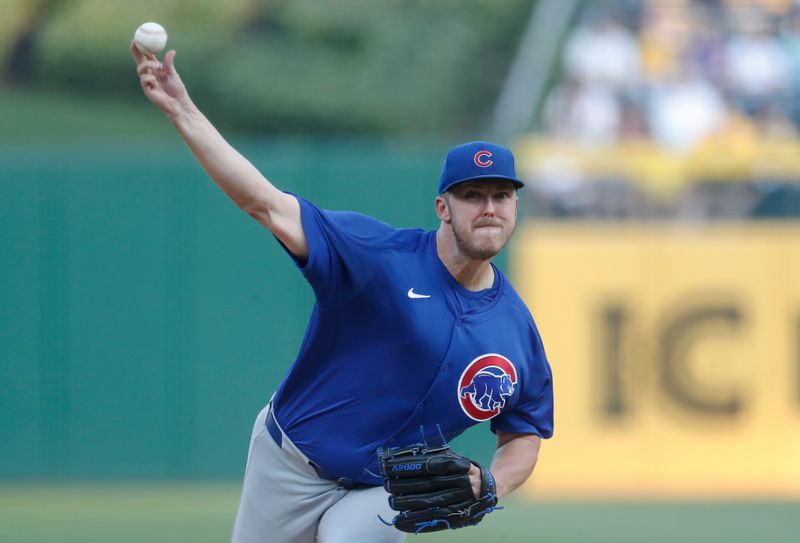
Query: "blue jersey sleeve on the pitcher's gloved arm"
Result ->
[[491, 333, 553, 439]]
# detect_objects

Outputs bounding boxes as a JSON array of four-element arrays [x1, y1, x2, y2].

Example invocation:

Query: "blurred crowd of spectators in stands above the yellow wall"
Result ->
[[528, 0, 800, 221]]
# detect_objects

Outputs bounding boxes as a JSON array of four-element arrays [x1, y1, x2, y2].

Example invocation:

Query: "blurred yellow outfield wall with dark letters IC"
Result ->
[[511, 223, 800, 498]]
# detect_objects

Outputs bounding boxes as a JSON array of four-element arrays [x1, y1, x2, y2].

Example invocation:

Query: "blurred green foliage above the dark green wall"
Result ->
[[0, 0, 535, 133]]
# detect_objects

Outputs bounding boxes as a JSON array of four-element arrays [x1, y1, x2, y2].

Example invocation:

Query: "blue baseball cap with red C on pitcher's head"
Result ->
[[439, 141, 525, 194]]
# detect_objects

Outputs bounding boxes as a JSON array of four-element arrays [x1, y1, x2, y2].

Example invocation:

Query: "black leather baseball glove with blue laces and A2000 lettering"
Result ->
[[378, 444, 502, 534]]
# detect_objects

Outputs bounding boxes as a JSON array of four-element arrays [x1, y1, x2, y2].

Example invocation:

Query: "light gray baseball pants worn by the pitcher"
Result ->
[[231, 404, 406, 543]]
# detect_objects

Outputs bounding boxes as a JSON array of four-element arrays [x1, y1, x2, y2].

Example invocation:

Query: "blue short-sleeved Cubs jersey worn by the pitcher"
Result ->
[[273, 197, 553, 485]]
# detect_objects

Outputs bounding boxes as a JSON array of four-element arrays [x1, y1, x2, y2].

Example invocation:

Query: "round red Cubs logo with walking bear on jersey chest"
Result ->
[[458, 353, 517, 421]]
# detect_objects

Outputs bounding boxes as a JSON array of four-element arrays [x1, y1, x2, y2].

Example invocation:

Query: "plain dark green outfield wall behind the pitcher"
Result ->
[[0, 138, 506, 479]]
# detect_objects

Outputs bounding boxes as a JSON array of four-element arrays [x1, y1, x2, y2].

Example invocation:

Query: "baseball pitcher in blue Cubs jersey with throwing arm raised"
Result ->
[[131, 40, 553, 543]]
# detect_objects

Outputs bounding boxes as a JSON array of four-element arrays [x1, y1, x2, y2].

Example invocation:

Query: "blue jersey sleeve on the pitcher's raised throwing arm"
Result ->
[[284, 194, 395, 308]]
